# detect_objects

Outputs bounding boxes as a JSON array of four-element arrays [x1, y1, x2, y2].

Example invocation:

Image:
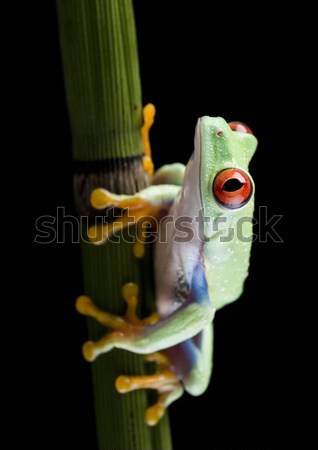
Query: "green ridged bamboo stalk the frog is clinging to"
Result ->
[[57, 0, 172, 450]]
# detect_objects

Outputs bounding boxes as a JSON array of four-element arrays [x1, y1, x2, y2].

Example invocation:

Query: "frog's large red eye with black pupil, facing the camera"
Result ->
[[213, 169, 253, 209]]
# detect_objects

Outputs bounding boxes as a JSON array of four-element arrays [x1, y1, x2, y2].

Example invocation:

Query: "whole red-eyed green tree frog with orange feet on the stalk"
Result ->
[[76, 105, 257, 426]]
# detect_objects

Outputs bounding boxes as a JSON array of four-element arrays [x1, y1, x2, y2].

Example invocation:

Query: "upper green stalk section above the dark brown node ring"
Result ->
[[57, 0, 142, 160]]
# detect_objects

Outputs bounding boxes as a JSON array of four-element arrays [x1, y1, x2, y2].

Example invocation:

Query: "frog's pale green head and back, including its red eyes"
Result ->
[[195, 117, 257, 309]]
